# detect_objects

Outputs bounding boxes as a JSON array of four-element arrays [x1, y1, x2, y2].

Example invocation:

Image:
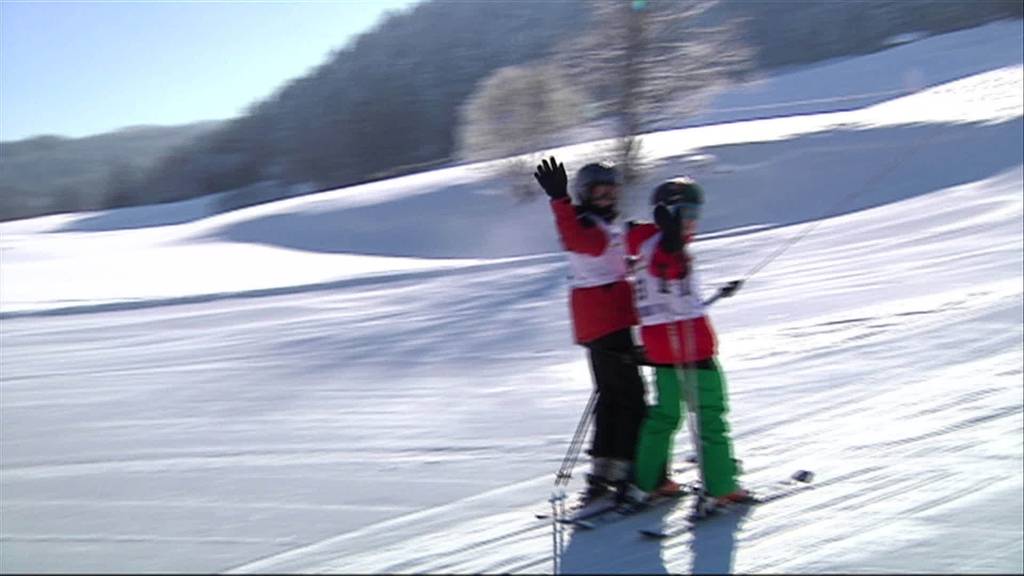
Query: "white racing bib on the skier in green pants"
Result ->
[[633, 234, 705, 326]]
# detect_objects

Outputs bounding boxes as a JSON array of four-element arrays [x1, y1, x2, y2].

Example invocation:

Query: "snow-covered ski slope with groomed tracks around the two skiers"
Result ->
[[0, 20, 1024, 573]]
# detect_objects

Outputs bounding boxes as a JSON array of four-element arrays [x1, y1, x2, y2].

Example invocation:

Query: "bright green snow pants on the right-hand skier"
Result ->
[[635, 359, 737, 496]]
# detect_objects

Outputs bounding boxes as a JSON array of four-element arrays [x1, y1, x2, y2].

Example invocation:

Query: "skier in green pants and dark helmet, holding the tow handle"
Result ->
[[626, 177, 750, 506]]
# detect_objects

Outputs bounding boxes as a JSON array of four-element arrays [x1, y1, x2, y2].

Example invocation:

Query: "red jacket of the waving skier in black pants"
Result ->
[[551, 198, 636, 344]]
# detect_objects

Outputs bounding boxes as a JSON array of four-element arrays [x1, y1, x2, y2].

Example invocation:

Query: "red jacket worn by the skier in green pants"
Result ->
[[626, 222, 718, 365]]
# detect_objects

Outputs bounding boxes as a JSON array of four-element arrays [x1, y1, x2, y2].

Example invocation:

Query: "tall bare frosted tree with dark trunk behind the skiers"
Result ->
[[557, 0, 753, 181]]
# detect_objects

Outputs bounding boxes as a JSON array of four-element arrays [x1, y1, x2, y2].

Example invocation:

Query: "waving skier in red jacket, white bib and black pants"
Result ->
[[534, 157, 646, 506]]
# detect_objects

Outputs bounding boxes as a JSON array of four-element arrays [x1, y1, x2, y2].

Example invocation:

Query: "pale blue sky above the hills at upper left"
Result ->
[[0, 0, 417, 141]]
